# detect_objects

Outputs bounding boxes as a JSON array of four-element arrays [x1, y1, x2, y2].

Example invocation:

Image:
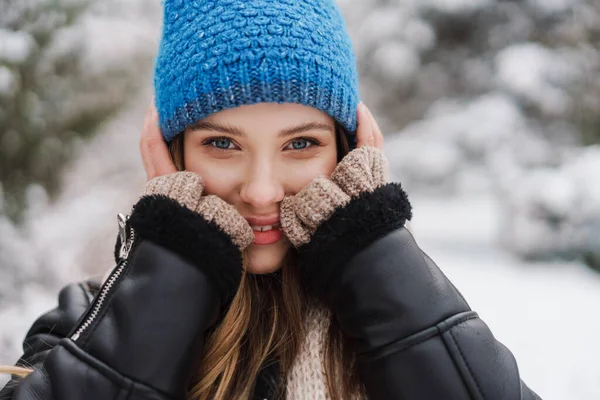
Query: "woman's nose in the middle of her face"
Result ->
[[240, 159, 285, 211]]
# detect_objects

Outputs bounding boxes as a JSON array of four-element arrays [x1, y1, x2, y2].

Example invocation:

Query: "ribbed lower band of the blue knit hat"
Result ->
[[155, 57, 358, 141]]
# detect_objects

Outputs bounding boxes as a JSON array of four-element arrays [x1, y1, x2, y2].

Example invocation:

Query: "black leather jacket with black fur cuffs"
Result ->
[[0, 184, 539, 400]]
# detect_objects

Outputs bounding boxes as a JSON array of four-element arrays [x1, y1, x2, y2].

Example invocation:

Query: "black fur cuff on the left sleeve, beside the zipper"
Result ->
[[129, 195, 242, 303]]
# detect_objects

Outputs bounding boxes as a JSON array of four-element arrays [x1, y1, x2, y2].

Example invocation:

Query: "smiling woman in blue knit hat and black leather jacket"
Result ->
[[0, 0, 538, 400]]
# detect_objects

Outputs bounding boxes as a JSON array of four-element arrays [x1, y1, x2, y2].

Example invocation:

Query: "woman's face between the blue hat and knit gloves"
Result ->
[[183, 103, 337, 274]]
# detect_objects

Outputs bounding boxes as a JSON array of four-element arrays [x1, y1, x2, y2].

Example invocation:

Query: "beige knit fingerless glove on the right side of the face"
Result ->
[[280, 147, 387, 247]]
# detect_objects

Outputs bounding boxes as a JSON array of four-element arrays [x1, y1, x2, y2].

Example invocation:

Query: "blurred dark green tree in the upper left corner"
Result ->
[[0, 0, 156, 220]]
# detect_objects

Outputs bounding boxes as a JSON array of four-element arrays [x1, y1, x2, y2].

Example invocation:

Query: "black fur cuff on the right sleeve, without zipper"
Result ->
[[298, 183, 412, 296]]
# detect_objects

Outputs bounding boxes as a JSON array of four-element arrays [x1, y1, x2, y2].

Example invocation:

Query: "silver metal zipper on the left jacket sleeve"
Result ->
[[71, 213, 135, 341]]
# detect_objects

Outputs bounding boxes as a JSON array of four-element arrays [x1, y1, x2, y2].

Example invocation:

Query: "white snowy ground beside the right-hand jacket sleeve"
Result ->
[[412, 196, 600, 400]]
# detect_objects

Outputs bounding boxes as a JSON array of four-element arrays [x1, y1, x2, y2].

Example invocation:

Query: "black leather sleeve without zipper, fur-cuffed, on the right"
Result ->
[[299, 184, 539, 400]]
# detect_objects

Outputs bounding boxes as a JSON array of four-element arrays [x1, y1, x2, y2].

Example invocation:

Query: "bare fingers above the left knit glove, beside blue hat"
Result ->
[[140, 98, 177, 180]]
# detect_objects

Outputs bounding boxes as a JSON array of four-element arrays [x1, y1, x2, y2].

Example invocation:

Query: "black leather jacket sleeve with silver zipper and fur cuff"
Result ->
[[3, 196, 242, 400]]
